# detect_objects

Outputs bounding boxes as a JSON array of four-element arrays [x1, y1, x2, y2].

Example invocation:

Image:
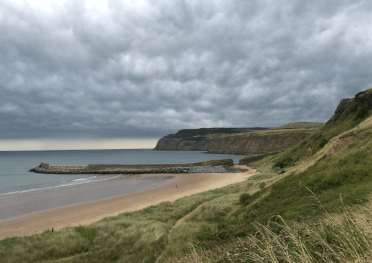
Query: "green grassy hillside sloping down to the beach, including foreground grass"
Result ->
[[0, 90, 372, 262]]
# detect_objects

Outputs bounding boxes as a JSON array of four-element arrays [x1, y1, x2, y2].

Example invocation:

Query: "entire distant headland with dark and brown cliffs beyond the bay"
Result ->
[[154, 122, 322, 155]]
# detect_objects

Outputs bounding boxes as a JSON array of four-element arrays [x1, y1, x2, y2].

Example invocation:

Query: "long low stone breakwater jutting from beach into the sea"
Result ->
[[30, 165, 239, 174]]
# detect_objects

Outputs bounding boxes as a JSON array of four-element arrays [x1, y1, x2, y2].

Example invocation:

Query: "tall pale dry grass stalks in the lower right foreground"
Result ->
[[174, 203, 372, 263]]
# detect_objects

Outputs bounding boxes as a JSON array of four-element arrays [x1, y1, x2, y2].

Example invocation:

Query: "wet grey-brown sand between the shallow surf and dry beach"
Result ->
[[0, 175, 177, 222]]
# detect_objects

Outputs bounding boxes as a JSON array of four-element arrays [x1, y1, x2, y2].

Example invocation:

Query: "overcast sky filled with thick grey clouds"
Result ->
[[0, 0, 372, 150]]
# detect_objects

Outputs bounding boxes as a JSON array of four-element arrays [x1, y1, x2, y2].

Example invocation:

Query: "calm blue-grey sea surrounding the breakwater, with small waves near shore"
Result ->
[[0, 149, 242, 195]]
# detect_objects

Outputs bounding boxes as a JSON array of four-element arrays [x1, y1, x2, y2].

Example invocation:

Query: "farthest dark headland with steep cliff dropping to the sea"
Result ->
[[154, 128, 266, 151]]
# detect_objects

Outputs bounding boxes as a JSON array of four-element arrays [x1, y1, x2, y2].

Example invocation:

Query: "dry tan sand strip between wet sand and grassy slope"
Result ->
[[0, 165, 256, 239]]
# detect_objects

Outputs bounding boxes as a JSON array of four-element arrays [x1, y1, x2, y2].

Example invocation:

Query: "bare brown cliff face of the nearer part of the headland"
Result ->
[[208, 132, 309, 155]]
